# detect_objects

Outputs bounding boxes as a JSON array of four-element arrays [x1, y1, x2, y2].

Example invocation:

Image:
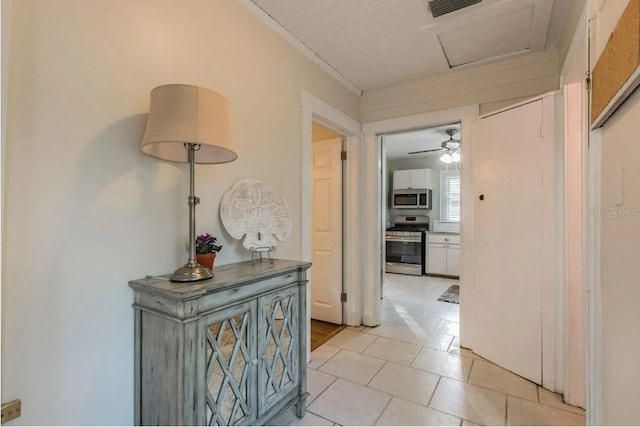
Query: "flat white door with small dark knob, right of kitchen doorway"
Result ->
[[473, 100, 543, 384]]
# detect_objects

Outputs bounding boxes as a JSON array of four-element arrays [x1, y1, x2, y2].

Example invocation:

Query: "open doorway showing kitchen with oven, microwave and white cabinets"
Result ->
[[378, 122, 461, 299]]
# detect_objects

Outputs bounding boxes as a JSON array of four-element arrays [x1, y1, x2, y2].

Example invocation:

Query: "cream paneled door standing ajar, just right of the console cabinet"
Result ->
[[311, 138, 342, 324]]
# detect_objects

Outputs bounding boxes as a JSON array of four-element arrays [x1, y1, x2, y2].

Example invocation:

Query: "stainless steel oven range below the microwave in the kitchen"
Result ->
[[385, 216, 429, 276]]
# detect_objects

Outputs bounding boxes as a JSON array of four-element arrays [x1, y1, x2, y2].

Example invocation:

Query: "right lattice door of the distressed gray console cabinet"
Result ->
[[258, 287, 300, 415]]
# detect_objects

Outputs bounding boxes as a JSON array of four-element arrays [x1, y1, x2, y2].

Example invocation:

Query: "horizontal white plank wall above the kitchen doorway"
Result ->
[[361, 50, 559, 123]]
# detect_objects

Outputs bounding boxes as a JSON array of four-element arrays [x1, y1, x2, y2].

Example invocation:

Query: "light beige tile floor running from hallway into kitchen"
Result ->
[[275, 274, 585, 425]]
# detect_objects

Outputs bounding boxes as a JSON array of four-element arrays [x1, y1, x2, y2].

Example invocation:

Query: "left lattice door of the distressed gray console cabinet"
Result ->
[[204, 301, 258, 425]]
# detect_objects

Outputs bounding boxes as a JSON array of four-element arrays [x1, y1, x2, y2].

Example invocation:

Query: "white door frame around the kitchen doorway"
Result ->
[[362, 104, 480, 326]]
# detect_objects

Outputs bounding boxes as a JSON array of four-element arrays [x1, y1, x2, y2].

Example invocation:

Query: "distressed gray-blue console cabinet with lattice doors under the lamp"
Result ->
[[129, 260, 311, 425]]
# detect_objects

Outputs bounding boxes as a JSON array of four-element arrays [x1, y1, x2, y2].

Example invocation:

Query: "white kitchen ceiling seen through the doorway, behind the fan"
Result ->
[[383, 123, 460, 160]]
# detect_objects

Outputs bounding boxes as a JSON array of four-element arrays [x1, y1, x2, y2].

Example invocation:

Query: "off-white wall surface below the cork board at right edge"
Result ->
[[594, 86, 640, 425]]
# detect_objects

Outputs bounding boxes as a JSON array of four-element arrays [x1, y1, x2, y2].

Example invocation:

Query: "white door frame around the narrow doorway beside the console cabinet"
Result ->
[[301, 90, 363, 338]]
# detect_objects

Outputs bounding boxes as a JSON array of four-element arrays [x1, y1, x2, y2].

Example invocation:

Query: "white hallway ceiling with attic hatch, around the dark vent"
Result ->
[[251, 0, 570, 90]]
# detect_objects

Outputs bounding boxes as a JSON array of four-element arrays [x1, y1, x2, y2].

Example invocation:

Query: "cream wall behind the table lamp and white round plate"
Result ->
[[2, 0, 359, 425]]
